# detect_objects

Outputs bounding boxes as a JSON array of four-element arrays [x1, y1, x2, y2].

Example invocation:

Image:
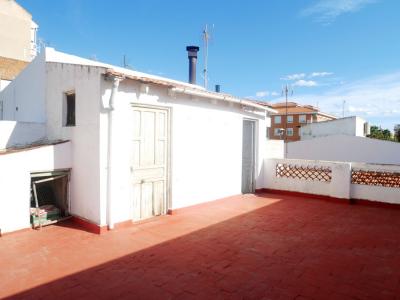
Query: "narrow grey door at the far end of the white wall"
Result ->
[[242, 120, 255, 194]]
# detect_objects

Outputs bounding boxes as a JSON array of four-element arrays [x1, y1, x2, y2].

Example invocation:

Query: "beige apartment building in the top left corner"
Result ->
[[0, 0, 38, 91]]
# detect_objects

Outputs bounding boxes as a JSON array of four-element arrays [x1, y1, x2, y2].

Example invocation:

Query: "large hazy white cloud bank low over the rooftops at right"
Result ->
[[296, 71, 400, 130]]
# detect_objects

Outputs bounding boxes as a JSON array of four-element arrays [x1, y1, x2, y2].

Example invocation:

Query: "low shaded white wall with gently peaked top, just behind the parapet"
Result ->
[[287, 135, 400, 165]]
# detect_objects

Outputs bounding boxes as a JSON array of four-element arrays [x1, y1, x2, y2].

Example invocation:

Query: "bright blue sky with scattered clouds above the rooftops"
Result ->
[[18, 0, 400, 129]]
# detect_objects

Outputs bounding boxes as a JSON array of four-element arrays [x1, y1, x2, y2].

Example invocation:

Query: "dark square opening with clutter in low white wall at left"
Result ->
[[30, 170, 70, 228]]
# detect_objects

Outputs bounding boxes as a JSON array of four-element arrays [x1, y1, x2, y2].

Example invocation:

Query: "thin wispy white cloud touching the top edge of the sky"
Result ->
[[300, 0, 378, 24]]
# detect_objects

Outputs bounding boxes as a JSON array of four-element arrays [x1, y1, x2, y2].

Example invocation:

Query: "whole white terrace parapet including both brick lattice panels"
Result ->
[[264, 159, 400, 204]]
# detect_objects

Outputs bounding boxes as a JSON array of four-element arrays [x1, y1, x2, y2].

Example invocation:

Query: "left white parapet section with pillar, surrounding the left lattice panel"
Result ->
[[264, 159, 351, 199]]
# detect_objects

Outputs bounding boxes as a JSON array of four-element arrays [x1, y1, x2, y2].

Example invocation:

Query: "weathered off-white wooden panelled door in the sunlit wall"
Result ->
[[131, 106, 169, 220]]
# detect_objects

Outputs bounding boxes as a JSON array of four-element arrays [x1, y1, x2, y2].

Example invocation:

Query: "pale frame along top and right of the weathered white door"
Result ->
[[130, 102, 172, 215]]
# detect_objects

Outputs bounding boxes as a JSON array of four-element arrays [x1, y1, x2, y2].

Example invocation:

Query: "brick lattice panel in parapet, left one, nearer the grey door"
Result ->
[[276, 164, 332, 182]]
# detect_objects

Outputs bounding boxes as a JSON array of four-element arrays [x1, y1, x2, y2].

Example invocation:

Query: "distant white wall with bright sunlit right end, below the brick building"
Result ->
[[300, 116, 366, 141]]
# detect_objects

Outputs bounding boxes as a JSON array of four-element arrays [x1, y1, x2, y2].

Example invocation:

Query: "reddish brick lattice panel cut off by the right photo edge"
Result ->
[[351, 170, 400, 188]]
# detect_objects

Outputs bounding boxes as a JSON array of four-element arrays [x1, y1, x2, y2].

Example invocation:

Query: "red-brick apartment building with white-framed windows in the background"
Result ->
[[268, 102, 336, 142]]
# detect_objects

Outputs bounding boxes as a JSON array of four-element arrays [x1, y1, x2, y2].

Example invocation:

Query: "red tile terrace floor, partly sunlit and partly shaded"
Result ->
[[0, 194, 400, 300]]
